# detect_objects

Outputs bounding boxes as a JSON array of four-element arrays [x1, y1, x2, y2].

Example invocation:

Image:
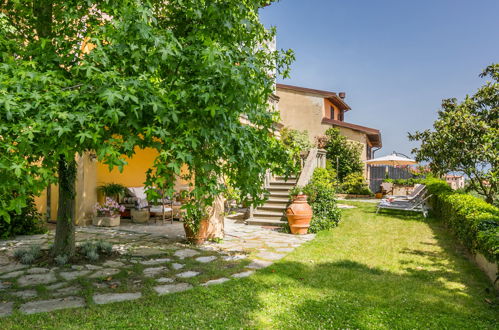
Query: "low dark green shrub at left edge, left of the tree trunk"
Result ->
[[0, 197, 46, 238]]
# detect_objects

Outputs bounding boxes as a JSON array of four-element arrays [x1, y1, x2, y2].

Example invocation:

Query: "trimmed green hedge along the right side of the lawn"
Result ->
[[426, 179, 499, 263]]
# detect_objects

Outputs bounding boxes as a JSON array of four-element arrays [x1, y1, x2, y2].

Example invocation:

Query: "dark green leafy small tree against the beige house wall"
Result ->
[[321, 127, 364, 182]]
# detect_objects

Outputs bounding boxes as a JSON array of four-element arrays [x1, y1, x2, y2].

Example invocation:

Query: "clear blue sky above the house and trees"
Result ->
[[261, 0, 499, 156]]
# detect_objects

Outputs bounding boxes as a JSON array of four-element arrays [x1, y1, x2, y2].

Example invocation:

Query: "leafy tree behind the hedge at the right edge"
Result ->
[[409, 64, 499, 203]]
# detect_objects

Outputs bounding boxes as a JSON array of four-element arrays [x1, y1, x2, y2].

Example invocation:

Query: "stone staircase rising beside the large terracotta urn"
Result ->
[[246, 177, 297, 226]]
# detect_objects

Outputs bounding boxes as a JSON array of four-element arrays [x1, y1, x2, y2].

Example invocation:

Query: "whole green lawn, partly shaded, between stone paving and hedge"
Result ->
[[0, 203, 499, 329]]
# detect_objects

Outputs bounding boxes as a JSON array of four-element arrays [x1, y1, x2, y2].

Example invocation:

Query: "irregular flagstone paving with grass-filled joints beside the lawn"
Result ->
[[0, 218, 314, 317]]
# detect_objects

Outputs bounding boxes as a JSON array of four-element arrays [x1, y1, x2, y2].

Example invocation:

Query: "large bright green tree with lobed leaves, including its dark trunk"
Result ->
[[0, 0, 292, 255]]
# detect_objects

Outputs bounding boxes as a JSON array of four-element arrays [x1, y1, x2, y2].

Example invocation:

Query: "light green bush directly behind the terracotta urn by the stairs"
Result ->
[[301, 168, 341, 233]]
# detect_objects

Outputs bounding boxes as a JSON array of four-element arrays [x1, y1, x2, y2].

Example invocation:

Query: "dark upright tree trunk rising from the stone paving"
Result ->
[[52, 156, 77, 257]]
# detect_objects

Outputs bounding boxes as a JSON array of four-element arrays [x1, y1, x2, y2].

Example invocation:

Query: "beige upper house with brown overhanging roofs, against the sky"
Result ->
[[277, 84, 382, 178]]
